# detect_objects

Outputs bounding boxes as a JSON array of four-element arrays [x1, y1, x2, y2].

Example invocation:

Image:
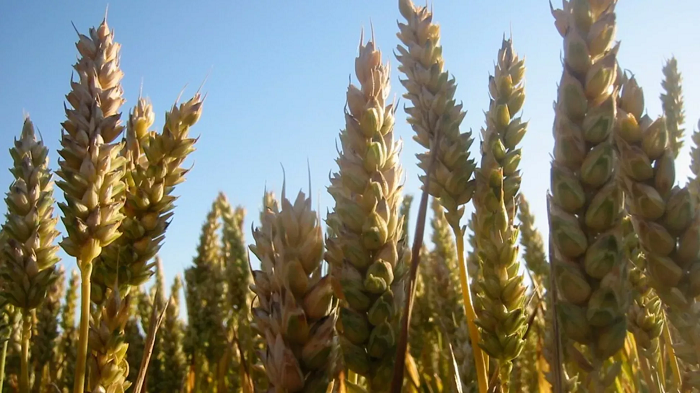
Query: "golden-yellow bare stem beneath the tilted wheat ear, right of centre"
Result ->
[[452, 228, 488, 393]]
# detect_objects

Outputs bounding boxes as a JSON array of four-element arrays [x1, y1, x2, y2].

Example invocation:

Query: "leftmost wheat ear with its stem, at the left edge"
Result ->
[[0, 118, 59, 393]]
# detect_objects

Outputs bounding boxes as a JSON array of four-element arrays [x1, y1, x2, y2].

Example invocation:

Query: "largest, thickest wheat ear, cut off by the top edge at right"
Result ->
[[548, 0, 627, 390]]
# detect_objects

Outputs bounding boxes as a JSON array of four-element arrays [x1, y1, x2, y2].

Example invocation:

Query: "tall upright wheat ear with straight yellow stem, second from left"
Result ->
[[56, 20, 125, 393]]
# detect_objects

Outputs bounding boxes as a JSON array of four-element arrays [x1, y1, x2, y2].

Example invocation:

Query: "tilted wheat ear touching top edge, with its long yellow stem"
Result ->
[[396, 0, 488, 393]]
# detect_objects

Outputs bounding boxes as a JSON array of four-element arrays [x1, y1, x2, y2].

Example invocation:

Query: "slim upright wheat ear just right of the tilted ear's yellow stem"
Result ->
[[474, 40, 527, 391]]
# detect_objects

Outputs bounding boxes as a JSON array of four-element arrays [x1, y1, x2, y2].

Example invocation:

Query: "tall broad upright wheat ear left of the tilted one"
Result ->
[[326, 31, 410, 391]]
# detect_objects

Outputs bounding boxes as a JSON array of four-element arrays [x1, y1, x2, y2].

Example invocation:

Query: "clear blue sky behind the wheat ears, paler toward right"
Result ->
[[0, 0, 700, 314]]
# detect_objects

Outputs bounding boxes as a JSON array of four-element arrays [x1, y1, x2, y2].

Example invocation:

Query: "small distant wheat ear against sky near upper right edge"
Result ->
[[661, 57, 685, 157]]
